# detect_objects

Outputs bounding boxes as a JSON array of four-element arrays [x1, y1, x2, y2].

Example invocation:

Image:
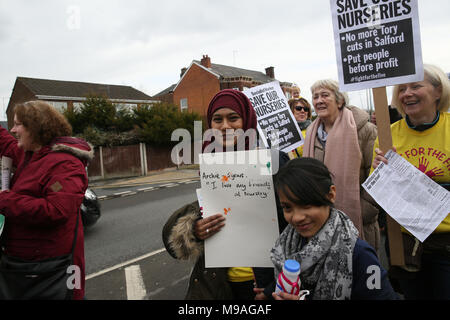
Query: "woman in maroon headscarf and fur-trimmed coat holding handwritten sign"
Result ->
[[163, 89, 288, 300]]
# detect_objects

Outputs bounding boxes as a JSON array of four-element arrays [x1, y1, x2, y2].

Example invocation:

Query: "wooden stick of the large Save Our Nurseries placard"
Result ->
[[372, 87, 405, 266]]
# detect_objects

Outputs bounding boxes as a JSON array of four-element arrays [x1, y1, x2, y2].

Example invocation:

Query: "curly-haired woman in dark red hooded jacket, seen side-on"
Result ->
[[0, 101, 93, 299]]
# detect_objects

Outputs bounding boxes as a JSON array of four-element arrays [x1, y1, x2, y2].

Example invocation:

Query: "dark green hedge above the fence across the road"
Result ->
[[63, 96, 201, 146]]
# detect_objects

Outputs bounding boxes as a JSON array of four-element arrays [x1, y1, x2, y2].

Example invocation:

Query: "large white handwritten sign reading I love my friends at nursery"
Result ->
[[200, 149, 278, 268]]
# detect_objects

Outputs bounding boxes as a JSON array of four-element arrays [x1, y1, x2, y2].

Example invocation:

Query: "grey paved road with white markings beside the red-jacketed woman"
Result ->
[[85, 181, 200, 300]]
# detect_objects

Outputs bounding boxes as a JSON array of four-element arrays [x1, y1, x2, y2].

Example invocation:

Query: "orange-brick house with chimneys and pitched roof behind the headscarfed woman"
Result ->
[[153, 55, 298, 116]]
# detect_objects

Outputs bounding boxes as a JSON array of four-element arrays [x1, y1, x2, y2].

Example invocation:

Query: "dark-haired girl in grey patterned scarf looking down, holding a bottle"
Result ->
[[271, 158, 397, 300]]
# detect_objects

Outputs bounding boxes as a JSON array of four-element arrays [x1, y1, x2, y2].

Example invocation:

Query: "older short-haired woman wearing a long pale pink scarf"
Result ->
[[303, 80, 380, 250]]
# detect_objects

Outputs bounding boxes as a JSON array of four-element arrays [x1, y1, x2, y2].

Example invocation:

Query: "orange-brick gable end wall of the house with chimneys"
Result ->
[[173, 64, 220, 115]]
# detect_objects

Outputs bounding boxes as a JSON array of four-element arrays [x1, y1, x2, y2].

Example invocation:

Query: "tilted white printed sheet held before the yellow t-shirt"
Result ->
[[363, 150, 450, 242]]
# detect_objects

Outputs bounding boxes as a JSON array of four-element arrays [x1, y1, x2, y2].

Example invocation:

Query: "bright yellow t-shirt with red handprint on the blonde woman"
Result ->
[[371, 112, 450, 233]]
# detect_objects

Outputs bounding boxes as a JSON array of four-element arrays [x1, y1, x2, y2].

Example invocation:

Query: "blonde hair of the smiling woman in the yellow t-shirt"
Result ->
[[391, 64, 450, 117]]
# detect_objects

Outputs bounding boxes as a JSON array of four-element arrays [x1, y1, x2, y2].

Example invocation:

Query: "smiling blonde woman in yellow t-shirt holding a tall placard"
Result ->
[[372, 65, 450, 299]]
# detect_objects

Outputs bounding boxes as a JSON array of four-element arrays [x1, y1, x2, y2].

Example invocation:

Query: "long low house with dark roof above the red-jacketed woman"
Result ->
[[6, 77, 158, 128]]
